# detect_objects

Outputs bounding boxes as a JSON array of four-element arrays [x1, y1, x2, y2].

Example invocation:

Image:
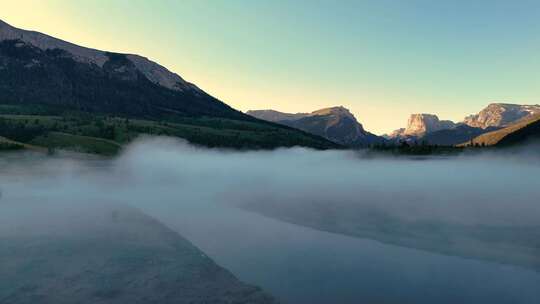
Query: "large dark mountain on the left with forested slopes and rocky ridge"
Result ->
[[0, 21, 339, 151]]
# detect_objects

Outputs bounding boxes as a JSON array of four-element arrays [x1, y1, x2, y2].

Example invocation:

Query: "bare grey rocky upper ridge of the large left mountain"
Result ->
[[0, 20, 198, 92]]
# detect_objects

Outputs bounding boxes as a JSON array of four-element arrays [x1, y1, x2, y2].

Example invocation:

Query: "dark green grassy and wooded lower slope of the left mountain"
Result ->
[[0, 106, 339, 155]]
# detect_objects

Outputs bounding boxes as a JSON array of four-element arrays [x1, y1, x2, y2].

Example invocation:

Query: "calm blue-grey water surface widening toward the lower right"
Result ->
[[149, 203, 540, 304]]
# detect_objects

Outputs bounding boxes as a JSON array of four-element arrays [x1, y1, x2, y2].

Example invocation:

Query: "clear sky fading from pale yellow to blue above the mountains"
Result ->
[[0, 0, 540, 134]]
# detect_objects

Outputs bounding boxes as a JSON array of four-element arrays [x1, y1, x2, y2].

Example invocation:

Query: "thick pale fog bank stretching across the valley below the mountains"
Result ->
[[0, 138, 540, 225]]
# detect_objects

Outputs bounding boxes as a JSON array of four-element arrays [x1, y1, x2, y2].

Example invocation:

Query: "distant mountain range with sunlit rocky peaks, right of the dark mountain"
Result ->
[[246, 103, 540, 147]]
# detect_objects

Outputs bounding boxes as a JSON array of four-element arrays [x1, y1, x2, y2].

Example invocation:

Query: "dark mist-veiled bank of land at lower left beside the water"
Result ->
[[0, 202, 276, 304]]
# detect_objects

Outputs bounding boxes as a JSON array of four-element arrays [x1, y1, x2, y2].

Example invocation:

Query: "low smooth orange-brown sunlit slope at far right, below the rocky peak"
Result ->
[[461, 113, 540, 146]]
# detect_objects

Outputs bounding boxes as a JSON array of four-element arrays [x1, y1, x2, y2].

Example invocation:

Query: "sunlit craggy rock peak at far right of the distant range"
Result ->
[[463, 103, 540, 129]]
